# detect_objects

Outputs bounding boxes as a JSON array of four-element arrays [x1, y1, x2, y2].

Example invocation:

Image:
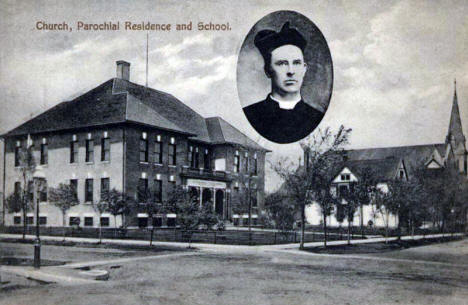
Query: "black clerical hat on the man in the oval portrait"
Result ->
[[254, 21, 307, 58]]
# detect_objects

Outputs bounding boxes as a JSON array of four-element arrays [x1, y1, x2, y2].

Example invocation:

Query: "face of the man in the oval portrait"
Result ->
[[267, 44, 307, 95]]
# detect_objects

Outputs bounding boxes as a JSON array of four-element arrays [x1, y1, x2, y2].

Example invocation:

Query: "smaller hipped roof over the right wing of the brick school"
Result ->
[[206, 117, 266, 150]]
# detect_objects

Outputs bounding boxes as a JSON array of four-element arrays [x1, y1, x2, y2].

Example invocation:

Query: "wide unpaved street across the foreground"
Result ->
[[0, 240, 468, 305]]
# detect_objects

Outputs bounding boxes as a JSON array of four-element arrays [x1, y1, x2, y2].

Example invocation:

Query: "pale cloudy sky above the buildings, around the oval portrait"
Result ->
[[0, 0, 468, 190]]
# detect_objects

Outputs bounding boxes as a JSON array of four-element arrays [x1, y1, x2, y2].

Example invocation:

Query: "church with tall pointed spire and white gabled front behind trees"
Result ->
[[306, 83, 468, 227]]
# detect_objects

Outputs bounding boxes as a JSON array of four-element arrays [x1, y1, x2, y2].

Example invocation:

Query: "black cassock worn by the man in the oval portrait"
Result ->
[[243, 95, 323, 144]]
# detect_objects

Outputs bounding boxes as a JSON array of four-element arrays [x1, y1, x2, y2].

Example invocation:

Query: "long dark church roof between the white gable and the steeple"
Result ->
[[346, 144, 447, 171]]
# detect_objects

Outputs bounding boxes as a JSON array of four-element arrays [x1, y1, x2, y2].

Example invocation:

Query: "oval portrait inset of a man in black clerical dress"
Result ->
[[237, 11, 333, 144]]
